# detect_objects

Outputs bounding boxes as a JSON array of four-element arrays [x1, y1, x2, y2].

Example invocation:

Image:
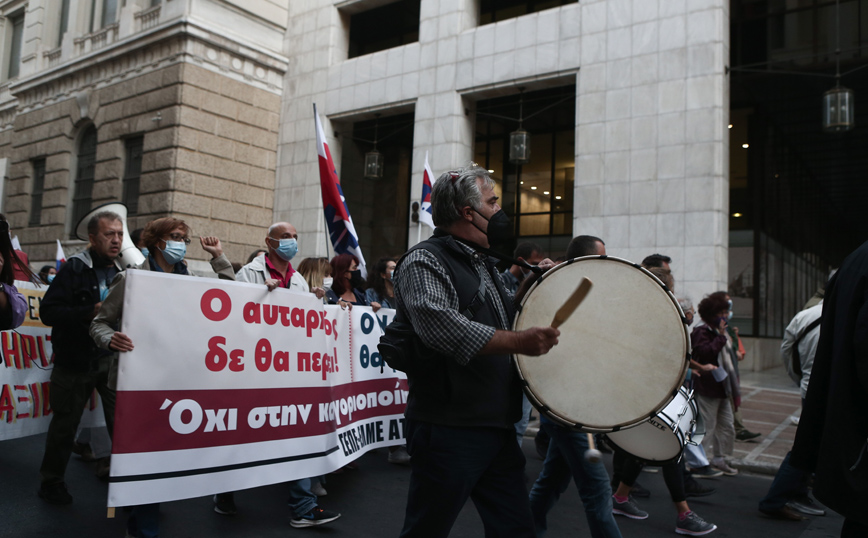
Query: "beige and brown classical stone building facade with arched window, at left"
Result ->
[[0, 0, 288, 272]]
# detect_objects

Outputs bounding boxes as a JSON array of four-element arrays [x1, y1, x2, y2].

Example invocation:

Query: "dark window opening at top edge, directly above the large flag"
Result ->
[[348, 0, 420, 58]]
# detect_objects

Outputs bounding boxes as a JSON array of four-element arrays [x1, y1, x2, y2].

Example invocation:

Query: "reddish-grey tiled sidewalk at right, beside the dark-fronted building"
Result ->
[[525, 366, 802, 475]]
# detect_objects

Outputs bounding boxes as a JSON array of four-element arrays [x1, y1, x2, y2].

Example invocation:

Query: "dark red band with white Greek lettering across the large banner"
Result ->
[[112, 378, 407, 454]]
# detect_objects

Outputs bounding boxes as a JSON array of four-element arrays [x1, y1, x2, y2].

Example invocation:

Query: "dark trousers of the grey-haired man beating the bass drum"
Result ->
[[401, 419, 534, 538]]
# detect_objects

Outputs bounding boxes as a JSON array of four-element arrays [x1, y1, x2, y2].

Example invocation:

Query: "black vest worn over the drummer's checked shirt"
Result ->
[[399, 228, 521, 428]]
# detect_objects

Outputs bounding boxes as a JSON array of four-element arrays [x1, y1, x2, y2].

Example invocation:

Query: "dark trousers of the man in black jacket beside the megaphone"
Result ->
[[39, 356, 115, 487]]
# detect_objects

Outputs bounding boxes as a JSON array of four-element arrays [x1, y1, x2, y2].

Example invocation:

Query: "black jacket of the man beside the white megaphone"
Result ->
[[39, 251, 118, 372]]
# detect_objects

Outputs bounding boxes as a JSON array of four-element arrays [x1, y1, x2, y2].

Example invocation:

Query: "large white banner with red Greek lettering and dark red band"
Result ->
[[108, 271, 407, 507]]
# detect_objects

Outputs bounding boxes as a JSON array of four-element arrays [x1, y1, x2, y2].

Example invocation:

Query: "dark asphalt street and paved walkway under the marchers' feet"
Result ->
[[0, 362, 843, 538]]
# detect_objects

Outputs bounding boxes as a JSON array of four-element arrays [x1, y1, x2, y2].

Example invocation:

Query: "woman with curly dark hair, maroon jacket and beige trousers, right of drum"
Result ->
[[690, 292, 739, 476]]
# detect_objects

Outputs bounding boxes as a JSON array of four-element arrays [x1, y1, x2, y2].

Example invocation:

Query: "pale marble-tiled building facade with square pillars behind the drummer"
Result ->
[[275, 0, 729, 306]]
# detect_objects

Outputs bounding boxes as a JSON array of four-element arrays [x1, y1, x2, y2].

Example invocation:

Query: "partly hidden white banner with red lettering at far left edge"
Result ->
[[0, 281, 105, 441]]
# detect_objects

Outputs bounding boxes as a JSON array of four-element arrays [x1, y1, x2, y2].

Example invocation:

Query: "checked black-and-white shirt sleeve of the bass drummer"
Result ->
[[393, 249, 494, 364]]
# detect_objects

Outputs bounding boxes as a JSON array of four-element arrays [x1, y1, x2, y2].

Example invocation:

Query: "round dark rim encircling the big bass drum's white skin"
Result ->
[[512, 254, 691, 433]]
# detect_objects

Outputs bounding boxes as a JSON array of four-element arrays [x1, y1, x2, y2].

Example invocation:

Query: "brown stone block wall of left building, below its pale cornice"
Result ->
[[0, 62, 280, 270]]
